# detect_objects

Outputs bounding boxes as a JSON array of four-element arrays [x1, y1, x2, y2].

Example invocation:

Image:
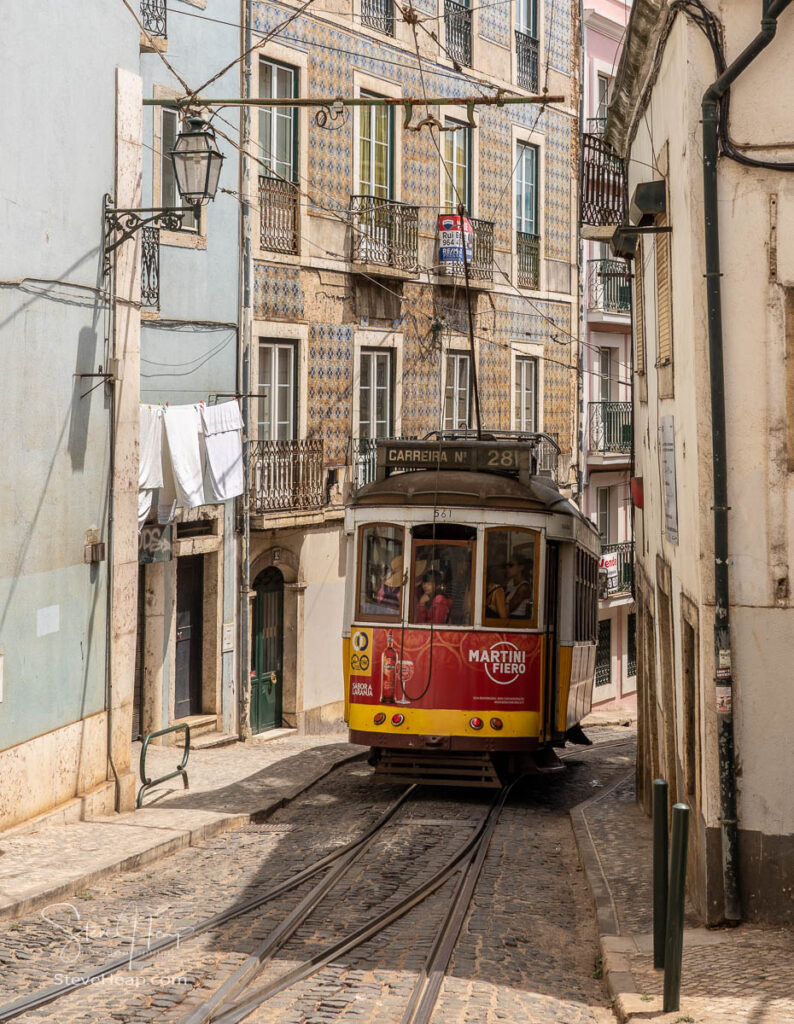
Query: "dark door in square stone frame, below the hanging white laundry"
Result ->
[[174, 555, 204, 720]]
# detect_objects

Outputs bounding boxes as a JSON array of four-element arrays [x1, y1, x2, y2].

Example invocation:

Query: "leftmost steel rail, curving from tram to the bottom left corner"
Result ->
[[0, 785, 416, 1024]]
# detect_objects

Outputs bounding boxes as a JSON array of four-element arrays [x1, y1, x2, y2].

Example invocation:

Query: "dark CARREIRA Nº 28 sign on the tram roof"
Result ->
[[378, 441, 530, 473]]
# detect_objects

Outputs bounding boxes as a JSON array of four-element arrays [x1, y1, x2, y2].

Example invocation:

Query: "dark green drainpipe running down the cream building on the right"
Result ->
[[702, 0, 792, 921]]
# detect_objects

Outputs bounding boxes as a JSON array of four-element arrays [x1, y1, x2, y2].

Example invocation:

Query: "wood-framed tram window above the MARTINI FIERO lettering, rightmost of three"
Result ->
[[483, 529, 540, 626]]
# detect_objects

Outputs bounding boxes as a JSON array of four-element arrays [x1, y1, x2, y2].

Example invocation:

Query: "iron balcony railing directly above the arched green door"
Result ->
[[248, 437, 326, 515]]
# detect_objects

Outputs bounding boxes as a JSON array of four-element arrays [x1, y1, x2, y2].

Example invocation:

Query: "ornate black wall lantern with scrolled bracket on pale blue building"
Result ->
[[102, 118, 223, 276]]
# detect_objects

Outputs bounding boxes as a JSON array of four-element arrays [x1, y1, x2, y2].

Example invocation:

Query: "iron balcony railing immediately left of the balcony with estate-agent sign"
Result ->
[[350, 196, 419, 271]]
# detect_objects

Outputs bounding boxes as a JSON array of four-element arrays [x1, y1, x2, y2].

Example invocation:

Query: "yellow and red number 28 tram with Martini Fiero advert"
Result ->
[[343, 433, 600, 785]]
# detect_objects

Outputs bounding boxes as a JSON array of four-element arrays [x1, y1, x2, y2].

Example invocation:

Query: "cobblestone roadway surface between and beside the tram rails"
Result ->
[[0, 728, 633, 1024]]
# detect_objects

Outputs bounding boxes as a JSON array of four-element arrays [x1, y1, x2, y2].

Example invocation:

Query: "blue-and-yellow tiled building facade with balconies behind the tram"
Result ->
[[243, 0, 581, 731]]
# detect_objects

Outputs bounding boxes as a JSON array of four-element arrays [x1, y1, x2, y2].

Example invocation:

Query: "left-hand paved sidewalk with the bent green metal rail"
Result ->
[[0, 735, 366, 919]]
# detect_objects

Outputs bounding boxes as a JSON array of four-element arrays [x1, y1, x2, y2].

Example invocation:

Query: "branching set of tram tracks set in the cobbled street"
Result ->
[[0, 738, 632, 1024]]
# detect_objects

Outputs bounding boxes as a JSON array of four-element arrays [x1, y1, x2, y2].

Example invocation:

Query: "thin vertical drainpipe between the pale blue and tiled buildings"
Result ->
[[238, 0, 253, 739]]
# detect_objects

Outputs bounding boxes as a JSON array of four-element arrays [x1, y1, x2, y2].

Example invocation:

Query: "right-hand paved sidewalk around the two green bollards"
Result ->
[[571, 749, 794, 1024]]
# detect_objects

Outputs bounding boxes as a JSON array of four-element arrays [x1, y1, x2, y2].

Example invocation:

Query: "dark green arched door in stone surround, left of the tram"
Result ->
[[251, 567, 284, 732]]
